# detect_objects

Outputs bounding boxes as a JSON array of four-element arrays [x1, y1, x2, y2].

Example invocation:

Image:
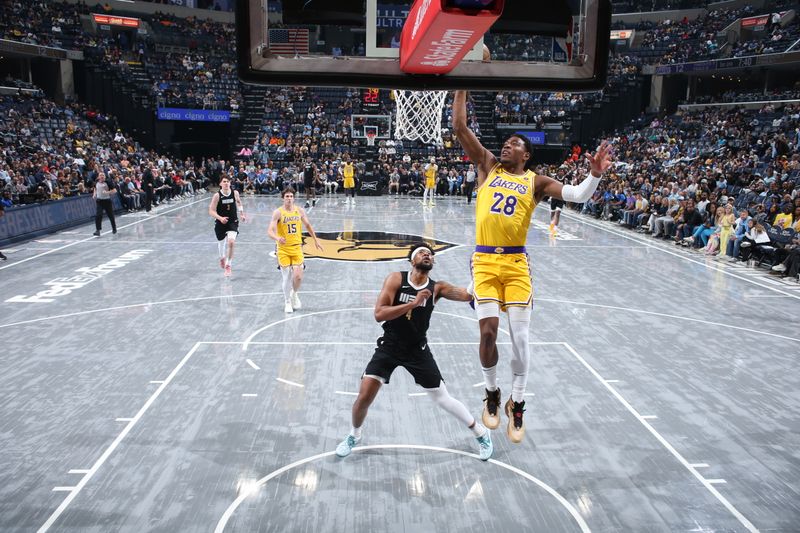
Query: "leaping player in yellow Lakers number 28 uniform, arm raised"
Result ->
[[453, 91, 611, 443]]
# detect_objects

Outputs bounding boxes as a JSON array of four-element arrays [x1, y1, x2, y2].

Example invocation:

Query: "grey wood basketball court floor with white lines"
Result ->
[[0, 196, 800, 532]]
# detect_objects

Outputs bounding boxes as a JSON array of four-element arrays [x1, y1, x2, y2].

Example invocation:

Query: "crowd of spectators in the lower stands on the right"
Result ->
[[545, 105, 800, 278]]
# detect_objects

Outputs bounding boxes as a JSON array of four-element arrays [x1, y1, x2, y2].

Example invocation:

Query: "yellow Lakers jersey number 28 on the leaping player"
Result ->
[[475, 164, 536, 246]]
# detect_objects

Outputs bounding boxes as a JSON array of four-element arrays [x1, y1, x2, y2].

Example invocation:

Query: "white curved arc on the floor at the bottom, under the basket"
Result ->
[[214, 444, 591, 533]]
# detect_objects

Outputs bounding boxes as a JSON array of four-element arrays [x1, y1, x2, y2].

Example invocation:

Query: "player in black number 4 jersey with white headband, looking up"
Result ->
[[336, 244, 494, 461]]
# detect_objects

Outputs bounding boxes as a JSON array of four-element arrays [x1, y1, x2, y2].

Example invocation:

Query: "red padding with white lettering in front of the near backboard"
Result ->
[[400, 0, 504, 74]]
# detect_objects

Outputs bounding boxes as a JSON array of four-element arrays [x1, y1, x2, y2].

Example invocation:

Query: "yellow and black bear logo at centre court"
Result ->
[[303, 231, 458, 261]]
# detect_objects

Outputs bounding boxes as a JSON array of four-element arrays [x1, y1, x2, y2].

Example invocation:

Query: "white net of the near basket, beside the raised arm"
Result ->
[[394, 89, 447, 145]]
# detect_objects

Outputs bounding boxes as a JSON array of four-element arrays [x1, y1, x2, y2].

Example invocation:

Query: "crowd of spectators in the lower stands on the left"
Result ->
[[0, 89, 223, 211]]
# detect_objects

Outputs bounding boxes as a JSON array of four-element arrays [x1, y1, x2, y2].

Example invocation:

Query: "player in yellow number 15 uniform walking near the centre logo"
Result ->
[[267, 188, 322, 313]]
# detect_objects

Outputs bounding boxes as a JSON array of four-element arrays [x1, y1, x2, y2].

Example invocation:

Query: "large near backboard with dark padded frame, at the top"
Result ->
[[236, 0, 611, 92]]
